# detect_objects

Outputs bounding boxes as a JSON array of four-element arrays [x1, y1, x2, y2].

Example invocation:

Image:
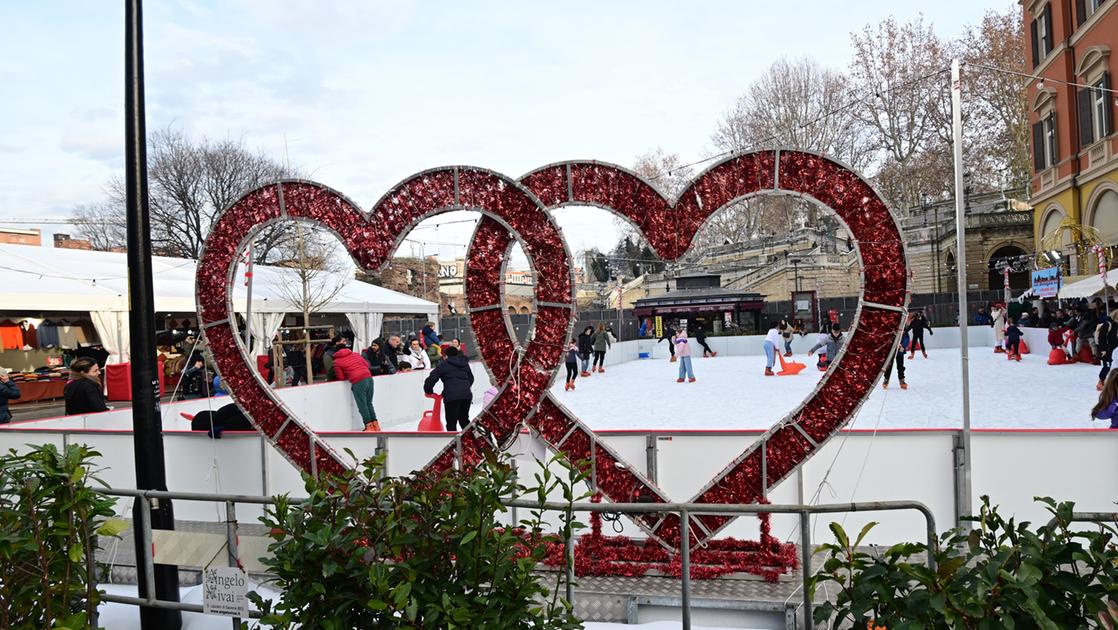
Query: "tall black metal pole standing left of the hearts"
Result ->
[[124, 0, 182, 630]]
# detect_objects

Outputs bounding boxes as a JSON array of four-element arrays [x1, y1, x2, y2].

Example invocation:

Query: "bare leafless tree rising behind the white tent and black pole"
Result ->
[[73, 127, 297, 264]]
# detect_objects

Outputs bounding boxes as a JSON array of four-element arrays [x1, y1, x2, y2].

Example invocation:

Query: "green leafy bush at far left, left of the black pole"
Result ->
[[0, 445, 123, 630]]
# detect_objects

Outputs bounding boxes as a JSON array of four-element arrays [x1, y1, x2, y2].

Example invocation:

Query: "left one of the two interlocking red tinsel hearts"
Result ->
[[197, 166, 572, 475]]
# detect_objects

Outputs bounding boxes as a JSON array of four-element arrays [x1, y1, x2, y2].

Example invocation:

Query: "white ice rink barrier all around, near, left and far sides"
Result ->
[[0, 326, 1082, 544]]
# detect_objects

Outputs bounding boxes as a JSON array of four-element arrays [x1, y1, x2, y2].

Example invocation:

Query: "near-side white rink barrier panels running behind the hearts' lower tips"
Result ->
[[0, 423, 1118, 544]]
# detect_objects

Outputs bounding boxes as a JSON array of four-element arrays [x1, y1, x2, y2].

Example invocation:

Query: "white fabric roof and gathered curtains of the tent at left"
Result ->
[[0, 245, 438, 361]]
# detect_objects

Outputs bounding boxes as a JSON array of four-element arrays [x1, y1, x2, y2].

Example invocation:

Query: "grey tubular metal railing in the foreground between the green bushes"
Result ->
[[89, 488, 938, 630]]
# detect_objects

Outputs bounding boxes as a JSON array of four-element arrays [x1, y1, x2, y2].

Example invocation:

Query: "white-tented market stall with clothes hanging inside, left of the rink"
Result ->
[[0, 245, 438, 395]]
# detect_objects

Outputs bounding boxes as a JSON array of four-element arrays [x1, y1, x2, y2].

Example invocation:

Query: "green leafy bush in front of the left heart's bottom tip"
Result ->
[[249, 456, 581, 630]]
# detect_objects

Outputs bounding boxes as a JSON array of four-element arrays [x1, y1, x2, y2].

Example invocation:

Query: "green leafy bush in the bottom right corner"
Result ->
[[809, 496, 1118, 630]]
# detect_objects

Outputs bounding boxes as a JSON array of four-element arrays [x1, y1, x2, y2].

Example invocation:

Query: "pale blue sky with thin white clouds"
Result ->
[[0, 0, 1016, 257]]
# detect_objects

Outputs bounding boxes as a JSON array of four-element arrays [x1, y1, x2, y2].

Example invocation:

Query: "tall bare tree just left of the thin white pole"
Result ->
[[850, 17, 950, 208]]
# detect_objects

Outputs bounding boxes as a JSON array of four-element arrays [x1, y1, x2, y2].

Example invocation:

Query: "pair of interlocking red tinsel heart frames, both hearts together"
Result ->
[[198, 151, 908, 546]]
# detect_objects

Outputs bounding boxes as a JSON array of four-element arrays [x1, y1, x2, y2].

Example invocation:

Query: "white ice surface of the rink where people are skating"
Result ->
[[541, 347, 1109, 429]]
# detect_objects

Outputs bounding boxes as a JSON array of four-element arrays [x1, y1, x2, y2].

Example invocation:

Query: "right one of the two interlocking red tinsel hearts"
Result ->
[[453, 151, 908, 544]]
